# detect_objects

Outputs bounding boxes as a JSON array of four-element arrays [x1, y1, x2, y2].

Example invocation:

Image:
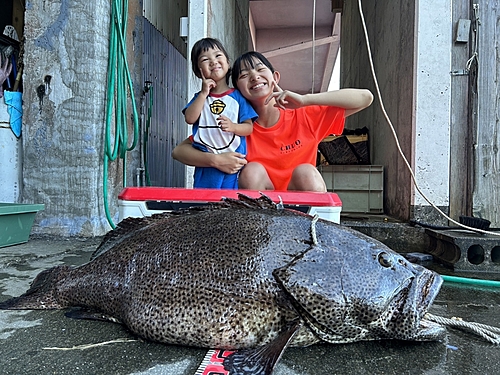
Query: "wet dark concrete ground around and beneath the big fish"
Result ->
[[0, 238, 500, 375]]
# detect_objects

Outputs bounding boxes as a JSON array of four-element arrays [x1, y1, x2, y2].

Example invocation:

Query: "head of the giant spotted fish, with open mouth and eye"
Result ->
[[273, 244, 446, 343]]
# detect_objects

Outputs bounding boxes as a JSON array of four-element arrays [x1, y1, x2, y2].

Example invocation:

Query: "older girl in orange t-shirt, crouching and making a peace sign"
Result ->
[[172, 52, 373, 192]]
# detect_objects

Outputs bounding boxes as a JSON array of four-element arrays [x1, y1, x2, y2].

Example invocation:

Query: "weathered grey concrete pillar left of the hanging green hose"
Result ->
[[22, 0, 115, 236]]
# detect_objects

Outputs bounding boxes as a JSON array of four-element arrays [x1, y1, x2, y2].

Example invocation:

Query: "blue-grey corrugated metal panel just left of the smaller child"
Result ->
[[142, 18, 187, 187]]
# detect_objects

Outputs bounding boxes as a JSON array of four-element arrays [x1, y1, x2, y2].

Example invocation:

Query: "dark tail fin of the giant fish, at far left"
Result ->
[[0, 266, 69, 310]]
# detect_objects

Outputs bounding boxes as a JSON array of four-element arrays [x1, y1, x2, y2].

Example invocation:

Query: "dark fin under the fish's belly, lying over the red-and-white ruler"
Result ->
[[224, 319, 302, 375]]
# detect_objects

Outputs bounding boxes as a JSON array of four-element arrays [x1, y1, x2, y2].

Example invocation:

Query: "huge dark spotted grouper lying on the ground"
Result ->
[[0, 195, 445, 374]]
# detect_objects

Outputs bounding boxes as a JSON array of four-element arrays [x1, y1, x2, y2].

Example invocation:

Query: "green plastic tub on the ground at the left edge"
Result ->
[[0, 203, 45, 247]]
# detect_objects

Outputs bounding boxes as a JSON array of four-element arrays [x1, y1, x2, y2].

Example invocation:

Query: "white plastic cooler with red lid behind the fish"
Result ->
[[118, 187, 342, 224]]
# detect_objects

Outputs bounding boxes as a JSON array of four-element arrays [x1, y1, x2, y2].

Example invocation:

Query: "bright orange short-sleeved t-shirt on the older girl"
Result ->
[[246, 105, 345, 190]]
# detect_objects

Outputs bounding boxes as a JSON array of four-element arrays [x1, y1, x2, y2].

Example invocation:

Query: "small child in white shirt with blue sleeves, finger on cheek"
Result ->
[[182, 38, 257, 189]]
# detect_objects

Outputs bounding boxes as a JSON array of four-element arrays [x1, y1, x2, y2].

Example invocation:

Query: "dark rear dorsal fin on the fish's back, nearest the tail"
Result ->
[[90, 213, 171, 260]]
